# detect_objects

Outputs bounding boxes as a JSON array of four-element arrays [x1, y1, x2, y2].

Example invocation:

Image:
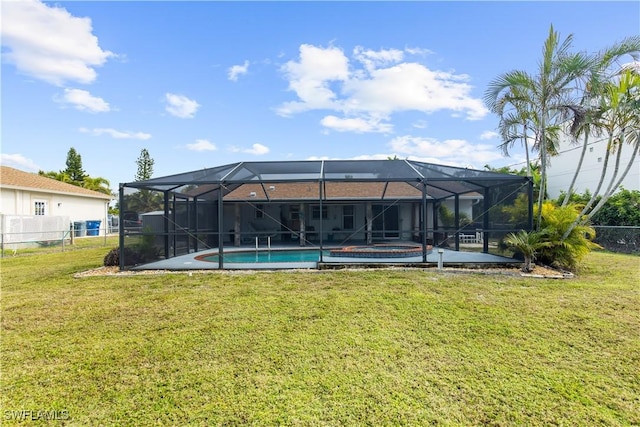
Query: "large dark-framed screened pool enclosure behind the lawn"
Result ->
[[119, 160, 533, 269]]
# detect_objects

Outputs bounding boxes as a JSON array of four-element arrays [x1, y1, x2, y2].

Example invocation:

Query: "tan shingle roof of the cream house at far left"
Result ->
[[0, 166, 112, 200]]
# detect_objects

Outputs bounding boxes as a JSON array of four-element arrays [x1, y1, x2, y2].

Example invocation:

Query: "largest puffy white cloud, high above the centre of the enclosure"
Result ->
[[276, 44, 488, 132]]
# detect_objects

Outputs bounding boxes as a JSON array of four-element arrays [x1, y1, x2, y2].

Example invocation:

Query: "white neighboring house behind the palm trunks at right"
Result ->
[[547, 137, 640, 199]]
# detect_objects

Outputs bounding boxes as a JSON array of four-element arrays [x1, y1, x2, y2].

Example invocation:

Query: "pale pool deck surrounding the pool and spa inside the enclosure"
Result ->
[[133, 246, 520, 270]]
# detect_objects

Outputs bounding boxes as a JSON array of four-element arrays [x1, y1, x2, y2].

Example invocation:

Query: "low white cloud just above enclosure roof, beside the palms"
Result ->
[[389, 135, 502, 169]]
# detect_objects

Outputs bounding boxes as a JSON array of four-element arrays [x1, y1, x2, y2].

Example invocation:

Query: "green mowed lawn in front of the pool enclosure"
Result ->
[[0, 247, 640, 426]]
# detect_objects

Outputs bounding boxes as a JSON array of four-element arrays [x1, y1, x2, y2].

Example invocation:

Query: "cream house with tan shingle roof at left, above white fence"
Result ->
[[0, 166, 113, 241]]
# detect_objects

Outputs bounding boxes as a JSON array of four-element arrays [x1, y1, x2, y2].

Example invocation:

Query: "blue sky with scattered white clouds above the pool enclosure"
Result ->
[[0, 0, 640, 191]]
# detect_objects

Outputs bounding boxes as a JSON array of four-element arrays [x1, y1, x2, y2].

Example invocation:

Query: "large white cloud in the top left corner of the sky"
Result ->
[[1, 0, 113, 86]]
